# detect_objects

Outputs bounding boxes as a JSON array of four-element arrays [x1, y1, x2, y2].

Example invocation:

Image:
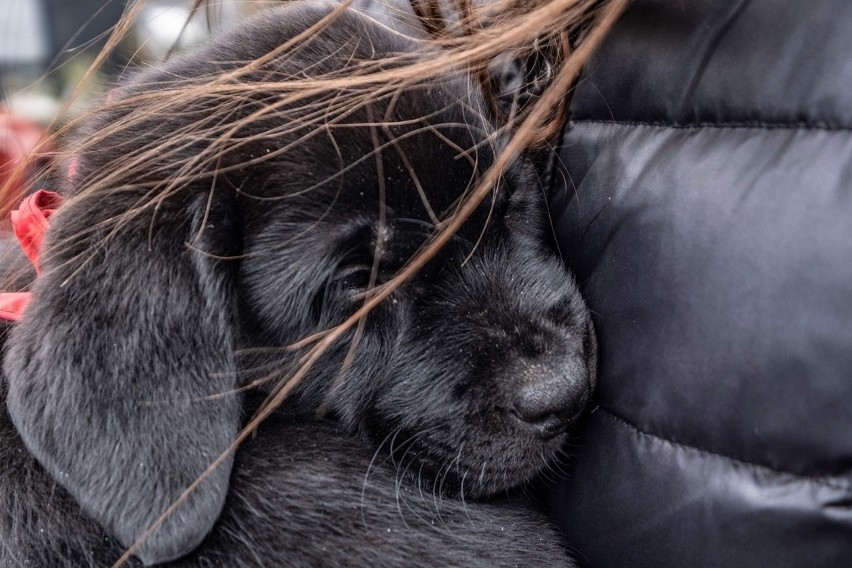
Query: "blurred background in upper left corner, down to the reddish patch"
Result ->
[[0, 0, 274, 202]]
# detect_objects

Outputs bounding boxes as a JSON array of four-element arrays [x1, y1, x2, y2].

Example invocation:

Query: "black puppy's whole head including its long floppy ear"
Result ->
[[4, 4, 595, 563]]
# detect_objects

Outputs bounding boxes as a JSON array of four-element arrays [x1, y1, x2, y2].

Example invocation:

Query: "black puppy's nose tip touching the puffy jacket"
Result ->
[[512, 357, 591, 439]]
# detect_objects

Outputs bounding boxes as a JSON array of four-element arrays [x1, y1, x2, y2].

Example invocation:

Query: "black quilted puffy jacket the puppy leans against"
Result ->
[[549, 0, 852, 568]]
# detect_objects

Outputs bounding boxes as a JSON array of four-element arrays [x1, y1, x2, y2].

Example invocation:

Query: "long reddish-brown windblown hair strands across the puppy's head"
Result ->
[[2, 0, 627, 558]]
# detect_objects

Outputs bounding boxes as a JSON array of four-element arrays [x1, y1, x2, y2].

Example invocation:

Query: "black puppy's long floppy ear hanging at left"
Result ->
[[5, 187, 241, 564]]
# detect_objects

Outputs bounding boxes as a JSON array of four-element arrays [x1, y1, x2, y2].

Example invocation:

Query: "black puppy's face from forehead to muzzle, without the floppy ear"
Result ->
[[223, 22, 596, 502]]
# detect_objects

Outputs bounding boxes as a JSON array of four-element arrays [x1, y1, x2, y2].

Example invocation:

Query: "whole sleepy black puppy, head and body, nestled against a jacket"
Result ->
[[0, 4, 595, 567]]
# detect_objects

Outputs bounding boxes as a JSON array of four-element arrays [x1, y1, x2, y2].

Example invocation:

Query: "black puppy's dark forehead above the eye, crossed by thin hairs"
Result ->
[[251, 86, 494, 220]]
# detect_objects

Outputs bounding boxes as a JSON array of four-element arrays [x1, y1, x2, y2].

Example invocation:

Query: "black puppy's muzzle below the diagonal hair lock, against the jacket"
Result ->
[[356, 176, 596, 497]]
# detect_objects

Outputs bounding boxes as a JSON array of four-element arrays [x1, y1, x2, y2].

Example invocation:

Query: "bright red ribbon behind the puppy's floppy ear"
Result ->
[[0, 189, 62, 321]]
